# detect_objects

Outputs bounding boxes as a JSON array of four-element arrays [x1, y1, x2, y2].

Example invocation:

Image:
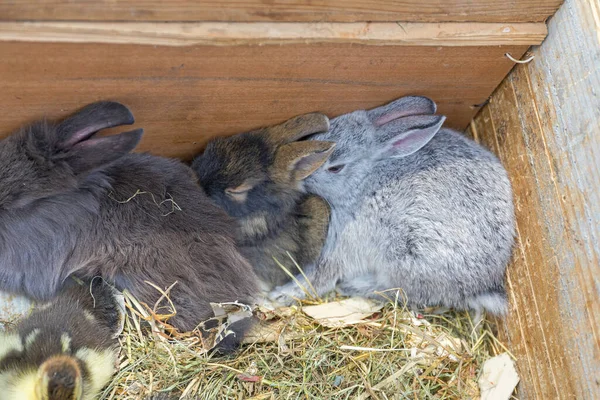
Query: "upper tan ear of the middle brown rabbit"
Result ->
[[266, 113, 329, 145]]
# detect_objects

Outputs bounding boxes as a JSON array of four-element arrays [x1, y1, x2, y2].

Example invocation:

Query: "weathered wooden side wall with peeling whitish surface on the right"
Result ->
[[470, 0, 600, 399]]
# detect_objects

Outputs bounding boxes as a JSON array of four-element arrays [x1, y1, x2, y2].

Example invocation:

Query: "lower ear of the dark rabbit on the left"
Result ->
[[64, 129, 144, 174]]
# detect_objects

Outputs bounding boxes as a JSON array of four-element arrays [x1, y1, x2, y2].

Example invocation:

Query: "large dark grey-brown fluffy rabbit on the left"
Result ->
[[0, 102, 257, 347]]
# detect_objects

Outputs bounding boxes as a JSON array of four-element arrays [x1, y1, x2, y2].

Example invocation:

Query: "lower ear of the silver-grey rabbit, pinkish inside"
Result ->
[[375, 115, 446, 158]]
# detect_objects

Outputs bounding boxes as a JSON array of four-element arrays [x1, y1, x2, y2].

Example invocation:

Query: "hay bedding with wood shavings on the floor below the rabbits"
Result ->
[[101, 290, 506, 400]]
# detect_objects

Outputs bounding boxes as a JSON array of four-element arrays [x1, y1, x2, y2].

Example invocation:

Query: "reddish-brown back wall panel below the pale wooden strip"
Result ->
[[0, 42, 526, 159]]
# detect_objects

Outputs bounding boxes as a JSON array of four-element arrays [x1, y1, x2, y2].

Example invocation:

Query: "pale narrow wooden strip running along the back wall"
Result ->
[[0, 22, 547, 46]]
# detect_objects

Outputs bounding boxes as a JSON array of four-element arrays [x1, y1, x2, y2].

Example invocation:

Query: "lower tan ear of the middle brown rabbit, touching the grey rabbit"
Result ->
[[271, 140, 335, 183]]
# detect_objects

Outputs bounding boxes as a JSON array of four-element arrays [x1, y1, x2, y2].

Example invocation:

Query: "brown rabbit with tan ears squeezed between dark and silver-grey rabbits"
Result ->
[[192, 113, 334, 289]]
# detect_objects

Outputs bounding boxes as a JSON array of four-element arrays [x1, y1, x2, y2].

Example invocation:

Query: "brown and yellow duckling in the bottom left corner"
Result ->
[[0, 279, 124, 400]]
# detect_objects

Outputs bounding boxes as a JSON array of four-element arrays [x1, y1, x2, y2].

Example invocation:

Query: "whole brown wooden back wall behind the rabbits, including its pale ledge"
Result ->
[[0, 0, 562, 160]]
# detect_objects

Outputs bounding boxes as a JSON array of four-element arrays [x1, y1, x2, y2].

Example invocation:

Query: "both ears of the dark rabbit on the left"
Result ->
[[57, 101, 144, 173]]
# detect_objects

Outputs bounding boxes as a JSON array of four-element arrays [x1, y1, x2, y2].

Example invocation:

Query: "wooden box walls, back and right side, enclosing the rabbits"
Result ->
[[0, 0, 600, 399]]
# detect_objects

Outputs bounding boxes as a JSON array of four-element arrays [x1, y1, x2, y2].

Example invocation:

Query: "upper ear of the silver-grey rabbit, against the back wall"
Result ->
[[367, 96, 437, 126]]
